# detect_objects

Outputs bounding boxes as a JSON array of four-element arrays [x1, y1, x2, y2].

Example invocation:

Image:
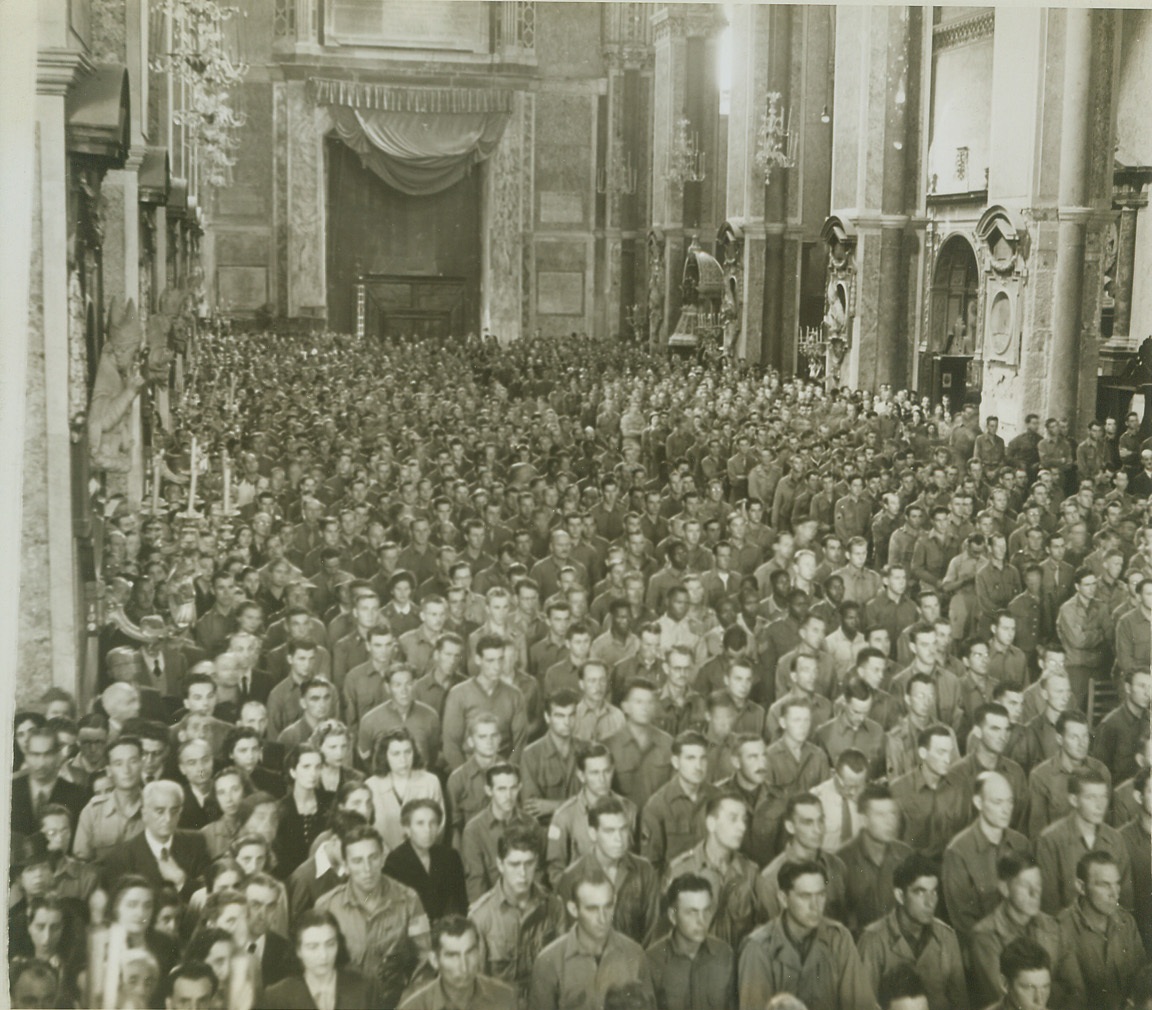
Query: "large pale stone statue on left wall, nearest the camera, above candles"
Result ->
[[88, 298, 144, 473]]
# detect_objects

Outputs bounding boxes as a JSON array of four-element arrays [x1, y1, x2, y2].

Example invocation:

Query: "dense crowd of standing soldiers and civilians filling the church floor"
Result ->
[[9, 324, 1152, 1010]]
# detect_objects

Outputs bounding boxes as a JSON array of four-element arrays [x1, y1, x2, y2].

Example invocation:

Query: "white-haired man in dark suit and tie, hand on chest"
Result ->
[[104, 779, 212, 901]]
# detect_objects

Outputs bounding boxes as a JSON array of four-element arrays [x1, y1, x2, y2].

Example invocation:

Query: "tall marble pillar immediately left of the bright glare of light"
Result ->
[[652, 3, 725, 343]]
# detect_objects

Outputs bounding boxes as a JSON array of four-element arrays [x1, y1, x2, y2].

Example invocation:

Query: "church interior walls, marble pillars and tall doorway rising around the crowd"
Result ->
[[0, 0, 1152, 1010]]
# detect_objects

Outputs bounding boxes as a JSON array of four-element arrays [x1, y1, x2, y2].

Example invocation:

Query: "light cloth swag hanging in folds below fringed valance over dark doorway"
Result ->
[[331, 105, 508, 196]]
